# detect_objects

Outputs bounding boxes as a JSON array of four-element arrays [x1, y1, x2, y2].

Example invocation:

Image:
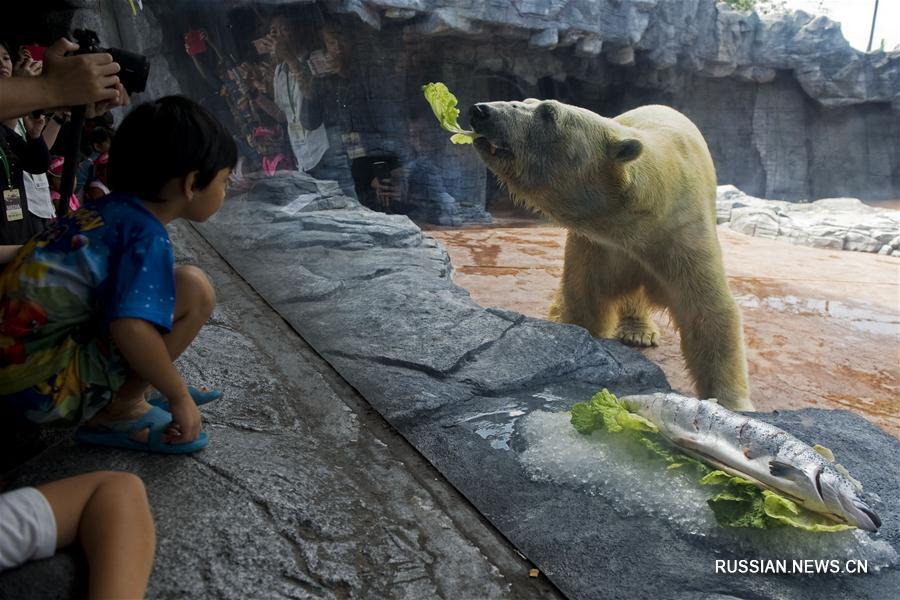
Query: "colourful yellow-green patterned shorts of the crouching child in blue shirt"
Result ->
[[0, 338, 128, 426]]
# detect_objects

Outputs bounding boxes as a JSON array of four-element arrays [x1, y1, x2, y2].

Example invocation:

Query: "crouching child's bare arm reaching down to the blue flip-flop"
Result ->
[[109, 318, 200, 443]]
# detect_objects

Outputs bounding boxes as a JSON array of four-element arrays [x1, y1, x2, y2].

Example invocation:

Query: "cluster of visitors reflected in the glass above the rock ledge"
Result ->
[[184, 11, 356, 198]]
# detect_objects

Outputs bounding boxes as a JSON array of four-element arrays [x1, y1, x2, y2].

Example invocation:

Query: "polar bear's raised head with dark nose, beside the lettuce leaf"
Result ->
[[469, 98, 643, 221]]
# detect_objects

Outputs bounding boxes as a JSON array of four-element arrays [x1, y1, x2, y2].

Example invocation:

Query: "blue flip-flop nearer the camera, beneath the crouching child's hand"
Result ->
[[75, 406, 209, 454]]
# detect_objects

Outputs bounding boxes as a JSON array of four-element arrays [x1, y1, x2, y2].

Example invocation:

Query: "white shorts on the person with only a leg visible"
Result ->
[[0, 487, 56, 571]]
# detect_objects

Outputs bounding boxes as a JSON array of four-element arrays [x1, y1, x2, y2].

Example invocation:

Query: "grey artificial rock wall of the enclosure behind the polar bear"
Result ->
[[63, 0, 900, 224]]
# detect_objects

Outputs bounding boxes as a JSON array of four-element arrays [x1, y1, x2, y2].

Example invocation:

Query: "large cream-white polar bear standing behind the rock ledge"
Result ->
[[469, 99, 753, 410]]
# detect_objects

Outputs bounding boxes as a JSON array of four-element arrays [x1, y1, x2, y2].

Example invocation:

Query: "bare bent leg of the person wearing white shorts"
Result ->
[[37, 471, 156, 598]]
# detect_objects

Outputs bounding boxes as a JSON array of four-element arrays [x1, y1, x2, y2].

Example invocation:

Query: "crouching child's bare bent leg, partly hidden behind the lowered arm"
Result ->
[[88, 266, 216, 432]]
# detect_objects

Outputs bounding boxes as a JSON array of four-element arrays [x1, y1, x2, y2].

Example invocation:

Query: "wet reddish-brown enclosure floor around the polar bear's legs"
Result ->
[[428, 220, 900, 437]]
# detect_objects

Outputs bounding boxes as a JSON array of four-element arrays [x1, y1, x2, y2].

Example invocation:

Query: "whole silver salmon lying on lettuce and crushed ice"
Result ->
[[620, 393, 881, 531]]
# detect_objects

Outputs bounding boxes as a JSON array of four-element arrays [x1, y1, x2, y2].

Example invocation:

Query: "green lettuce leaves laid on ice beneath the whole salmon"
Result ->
[[572, 389, 853, 531]]
